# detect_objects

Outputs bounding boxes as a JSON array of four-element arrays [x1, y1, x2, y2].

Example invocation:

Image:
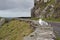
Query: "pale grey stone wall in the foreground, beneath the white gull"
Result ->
[[24, 21, 55, 40]]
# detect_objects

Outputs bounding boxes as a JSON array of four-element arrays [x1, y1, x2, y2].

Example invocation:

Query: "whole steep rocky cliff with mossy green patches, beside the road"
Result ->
[[31, 0, 60, 18]]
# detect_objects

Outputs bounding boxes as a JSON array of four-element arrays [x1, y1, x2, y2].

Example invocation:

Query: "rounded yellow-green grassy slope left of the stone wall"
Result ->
[[0, 20, 33, 40]]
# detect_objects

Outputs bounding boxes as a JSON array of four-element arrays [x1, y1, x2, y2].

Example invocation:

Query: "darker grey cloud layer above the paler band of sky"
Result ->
[[0, 0, 33, 10]]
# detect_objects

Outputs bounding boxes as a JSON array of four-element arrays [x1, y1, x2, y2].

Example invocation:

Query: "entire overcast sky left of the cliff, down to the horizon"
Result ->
[[0, 0, 34, 17]]
